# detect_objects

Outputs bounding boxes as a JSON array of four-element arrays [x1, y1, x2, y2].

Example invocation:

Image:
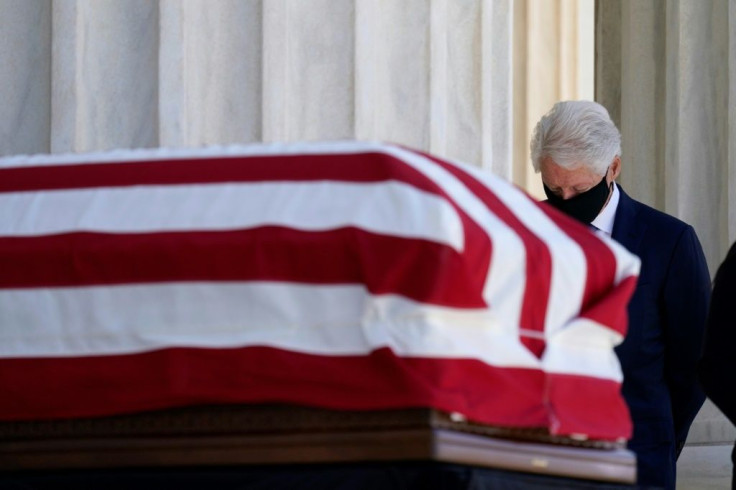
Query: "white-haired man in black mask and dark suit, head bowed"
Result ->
[[531, 101, 710, 489]]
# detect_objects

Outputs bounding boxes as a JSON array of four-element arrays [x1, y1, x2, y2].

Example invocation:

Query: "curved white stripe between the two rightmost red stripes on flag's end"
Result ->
[[436, 159, 587, 336]]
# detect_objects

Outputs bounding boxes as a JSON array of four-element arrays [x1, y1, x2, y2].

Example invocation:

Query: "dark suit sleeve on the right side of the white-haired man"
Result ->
[[664, 226, 711, 450]]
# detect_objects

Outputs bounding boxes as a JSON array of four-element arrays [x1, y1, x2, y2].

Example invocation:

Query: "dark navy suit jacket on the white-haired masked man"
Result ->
[[612, 187, 711, 488]]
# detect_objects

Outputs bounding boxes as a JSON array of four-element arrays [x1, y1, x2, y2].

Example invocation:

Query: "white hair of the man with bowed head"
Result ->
[[529, 100, 621, 175]]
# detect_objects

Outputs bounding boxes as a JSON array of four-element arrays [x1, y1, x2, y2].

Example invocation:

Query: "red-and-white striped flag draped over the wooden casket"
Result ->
[[0, 142, 639, 440]]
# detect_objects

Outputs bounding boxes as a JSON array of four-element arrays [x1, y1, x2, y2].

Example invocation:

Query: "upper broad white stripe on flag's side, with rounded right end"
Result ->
[[0, 181, 464, 250]]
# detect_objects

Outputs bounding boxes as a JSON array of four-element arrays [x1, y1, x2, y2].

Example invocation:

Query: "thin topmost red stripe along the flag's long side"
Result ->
[[0, 152, 442, 194]]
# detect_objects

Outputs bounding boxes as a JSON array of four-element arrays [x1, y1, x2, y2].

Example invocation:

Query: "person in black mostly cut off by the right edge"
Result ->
[[699, 242, 736, 490]]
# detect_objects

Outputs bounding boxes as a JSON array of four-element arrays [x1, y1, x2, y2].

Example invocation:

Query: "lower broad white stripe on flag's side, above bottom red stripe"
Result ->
[[0, 282, 539, 368]]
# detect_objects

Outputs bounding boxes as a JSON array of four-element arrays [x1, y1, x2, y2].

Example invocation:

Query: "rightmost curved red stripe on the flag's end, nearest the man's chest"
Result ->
[[541, 203, 636, 334]]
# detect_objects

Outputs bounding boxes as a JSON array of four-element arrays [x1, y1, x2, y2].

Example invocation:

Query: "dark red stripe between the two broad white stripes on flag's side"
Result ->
[[0, 227, 488, 308]]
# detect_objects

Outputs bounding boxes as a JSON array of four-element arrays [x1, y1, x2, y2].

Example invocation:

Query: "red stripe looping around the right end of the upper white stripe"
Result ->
[[0, 152, 491, 307]]
